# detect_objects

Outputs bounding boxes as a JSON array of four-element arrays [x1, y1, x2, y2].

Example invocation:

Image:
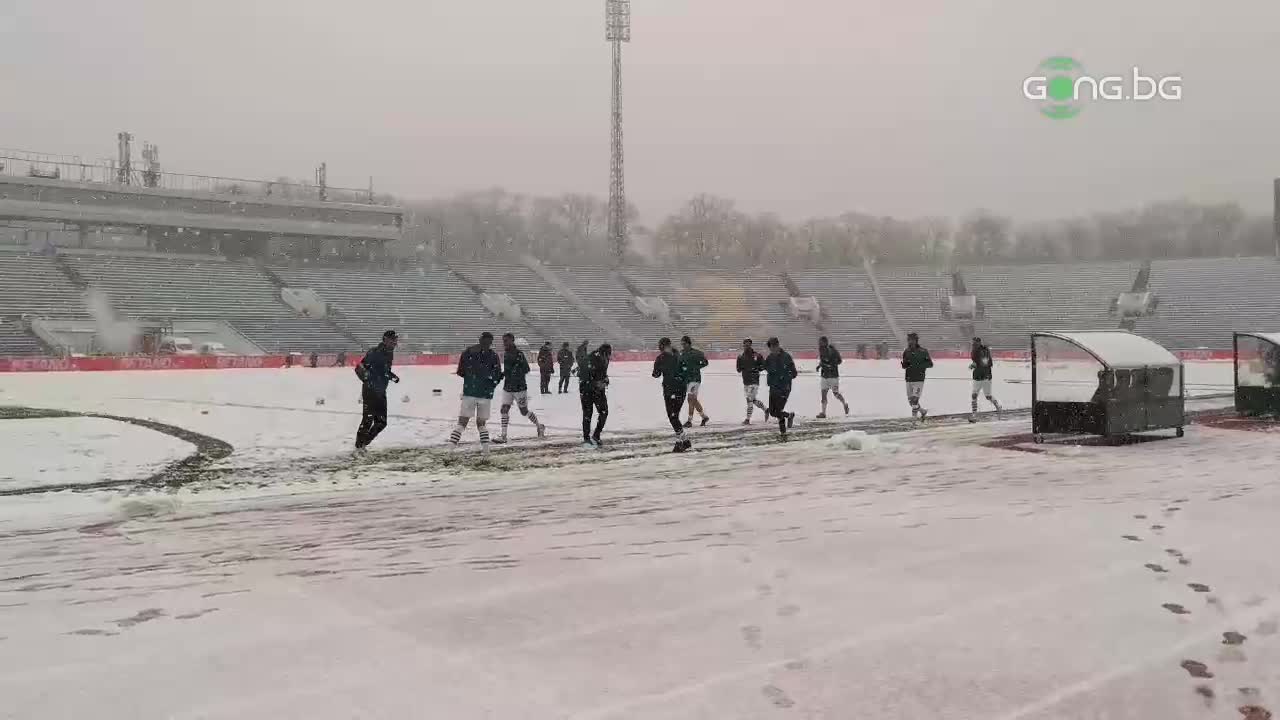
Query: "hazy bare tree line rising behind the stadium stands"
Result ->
[[393, 188, 1276, 269]]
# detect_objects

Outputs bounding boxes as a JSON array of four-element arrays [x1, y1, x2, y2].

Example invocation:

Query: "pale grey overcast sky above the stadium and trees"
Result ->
[[0, 0, 1280, 220]]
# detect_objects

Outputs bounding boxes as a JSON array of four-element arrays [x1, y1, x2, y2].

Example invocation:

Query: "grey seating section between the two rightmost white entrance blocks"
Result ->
[[962, 261, 1140, 350]]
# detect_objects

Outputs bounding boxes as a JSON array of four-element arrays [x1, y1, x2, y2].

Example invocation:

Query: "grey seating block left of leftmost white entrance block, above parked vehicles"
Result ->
[[65, 254, 294, 320]]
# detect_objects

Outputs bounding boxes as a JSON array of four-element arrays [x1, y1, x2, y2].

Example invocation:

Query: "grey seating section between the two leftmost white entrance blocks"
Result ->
[[271, 266, 534, 352]]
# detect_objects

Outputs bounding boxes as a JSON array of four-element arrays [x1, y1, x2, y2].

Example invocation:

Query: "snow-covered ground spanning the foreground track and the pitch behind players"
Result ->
[[0, 364, 1280, 720]]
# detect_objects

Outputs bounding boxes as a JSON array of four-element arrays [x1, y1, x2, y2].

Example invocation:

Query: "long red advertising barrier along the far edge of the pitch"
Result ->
[[0, 350, 1233, 373]]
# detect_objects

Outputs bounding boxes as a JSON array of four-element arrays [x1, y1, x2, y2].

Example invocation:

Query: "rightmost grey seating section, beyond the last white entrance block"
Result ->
[[1137, 258, 1280, 350]]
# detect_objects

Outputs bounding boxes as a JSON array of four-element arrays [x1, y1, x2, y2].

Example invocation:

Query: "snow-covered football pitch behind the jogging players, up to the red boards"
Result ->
[[0, 360, 1231, 464]]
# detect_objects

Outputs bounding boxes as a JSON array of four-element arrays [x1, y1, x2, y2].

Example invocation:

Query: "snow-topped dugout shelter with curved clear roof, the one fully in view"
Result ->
[[1030, 329, 1187, 442]]
